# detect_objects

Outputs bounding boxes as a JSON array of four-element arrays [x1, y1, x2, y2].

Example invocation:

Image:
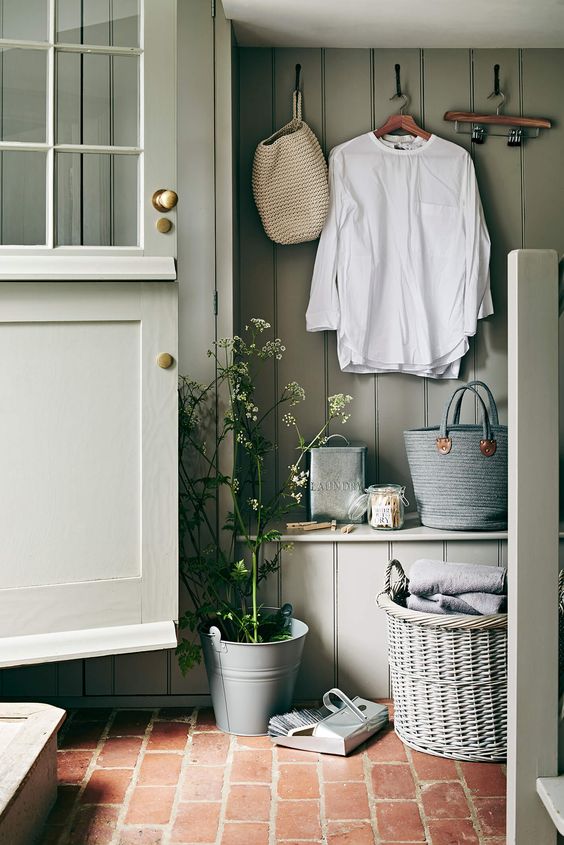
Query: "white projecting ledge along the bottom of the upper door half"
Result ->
[[0, 254, 177, 282]]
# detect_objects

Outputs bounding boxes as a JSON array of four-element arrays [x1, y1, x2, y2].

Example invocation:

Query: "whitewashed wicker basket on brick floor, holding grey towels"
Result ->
[[376, 560, 507, 763]]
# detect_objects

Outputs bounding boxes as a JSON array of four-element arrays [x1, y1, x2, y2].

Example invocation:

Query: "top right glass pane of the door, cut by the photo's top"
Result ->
[[56, 0, 139, 47]]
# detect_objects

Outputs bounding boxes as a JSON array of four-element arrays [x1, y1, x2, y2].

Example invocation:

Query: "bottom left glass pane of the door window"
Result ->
[[0, 150, 47, 246]]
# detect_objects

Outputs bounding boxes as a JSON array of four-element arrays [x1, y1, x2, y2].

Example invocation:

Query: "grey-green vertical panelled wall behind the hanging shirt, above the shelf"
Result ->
[[238, 48, 564, 516]]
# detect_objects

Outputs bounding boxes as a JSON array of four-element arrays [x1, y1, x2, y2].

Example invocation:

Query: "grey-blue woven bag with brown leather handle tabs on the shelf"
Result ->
[[404, 381, 507, 531]]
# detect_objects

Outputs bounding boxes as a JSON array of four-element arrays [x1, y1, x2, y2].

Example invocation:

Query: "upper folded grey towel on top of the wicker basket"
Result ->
[[409, 558, 507, 596]]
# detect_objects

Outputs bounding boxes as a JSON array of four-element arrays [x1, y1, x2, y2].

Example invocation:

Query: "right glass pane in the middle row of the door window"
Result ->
[[57, 52, 139, 147]]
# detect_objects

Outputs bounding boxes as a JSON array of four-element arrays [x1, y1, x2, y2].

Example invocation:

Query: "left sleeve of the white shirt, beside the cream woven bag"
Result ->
[[306, 148, 341, 332]]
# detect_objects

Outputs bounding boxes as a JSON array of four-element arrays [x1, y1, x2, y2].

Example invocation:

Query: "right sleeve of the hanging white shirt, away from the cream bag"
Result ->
[[463, 155, 493, 337]]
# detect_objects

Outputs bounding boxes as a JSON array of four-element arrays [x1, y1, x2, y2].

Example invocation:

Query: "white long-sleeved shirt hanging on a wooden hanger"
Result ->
[[306, 132, 493, 378]]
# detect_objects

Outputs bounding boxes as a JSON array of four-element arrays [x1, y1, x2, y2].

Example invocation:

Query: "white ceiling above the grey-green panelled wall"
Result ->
[[223, 0, 564, 48]]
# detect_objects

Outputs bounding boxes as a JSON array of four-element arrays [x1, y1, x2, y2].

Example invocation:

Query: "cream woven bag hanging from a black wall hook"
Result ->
[[253, 90, 329, 244]]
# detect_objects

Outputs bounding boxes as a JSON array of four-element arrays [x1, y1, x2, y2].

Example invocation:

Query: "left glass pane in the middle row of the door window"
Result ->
[[0, 48, 47, 143]]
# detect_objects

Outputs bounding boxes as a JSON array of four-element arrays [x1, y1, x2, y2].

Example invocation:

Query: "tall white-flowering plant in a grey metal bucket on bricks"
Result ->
[[177, 319, 352, 734]]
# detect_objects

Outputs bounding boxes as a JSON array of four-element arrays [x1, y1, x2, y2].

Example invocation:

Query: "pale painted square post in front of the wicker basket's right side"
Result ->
[[507, 250, 559, 845]]
